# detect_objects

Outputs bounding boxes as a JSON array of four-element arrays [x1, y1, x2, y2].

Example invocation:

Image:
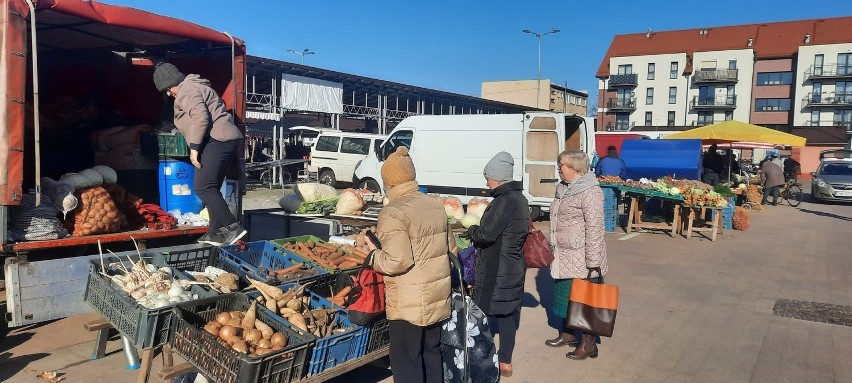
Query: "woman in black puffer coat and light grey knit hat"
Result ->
[[468, 152, 529, 376]]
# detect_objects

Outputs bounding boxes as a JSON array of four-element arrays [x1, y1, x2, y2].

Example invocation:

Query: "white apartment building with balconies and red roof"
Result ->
[[596, 17, 852, 143]]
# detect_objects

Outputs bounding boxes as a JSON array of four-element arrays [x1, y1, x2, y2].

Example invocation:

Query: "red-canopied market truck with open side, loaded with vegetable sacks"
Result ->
[[0, 0, 246, 327]]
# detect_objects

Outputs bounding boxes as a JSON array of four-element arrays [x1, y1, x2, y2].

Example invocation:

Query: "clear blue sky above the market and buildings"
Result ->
[[104, 0, 852, 104]]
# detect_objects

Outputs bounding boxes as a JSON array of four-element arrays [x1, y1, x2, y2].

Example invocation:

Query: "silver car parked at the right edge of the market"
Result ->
[[811, 149, 852, 202]]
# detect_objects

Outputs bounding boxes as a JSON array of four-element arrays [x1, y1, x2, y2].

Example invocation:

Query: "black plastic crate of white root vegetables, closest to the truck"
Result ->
[[84, 252, 216, 349]]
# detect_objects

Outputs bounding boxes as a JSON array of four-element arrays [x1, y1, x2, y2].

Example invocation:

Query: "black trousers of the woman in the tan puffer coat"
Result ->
[[388, 320, 444, 383]]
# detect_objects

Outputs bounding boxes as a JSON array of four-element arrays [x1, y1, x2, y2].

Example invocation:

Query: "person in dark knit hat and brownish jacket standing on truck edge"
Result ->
[[154, 63, 248, 246]]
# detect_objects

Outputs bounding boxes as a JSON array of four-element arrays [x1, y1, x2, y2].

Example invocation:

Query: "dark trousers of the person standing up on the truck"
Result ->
[[193, 138, 240, 233]]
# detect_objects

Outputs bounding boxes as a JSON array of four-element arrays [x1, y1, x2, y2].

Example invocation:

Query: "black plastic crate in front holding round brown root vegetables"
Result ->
[[170, 294, 314, 383]]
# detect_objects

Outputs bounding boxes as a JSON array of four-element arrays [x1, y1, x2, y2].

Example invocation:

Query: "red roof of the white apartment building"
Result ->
[[595, 16, 852, 78]]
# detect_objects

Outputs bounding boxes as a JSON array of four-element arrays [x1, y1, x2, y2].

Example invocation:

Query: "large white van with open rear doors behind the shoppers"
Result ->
[[355, 112, 595, 217]]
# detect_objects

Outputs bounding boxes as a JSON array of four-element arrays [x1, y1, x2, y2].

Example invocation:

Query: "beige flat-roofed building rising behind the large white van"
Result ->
[[480, 79, 589, 116]]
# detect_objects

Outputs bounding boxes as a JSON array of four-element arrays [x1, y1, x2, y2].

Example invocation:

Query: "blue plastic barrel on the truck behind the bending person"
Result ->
[[157, 160, 202, 214]]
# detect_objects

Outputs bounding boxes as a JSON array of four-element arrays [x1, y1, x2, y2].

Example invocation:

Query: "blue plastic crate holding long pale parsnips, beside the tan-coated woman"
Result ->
[[248, 283, 369, 376]]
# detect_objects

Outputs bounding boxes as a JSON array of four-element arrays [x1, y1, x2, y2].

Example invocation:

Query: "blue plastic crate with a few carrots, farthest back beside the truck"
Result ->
[[219, 241, 326, 284]]
